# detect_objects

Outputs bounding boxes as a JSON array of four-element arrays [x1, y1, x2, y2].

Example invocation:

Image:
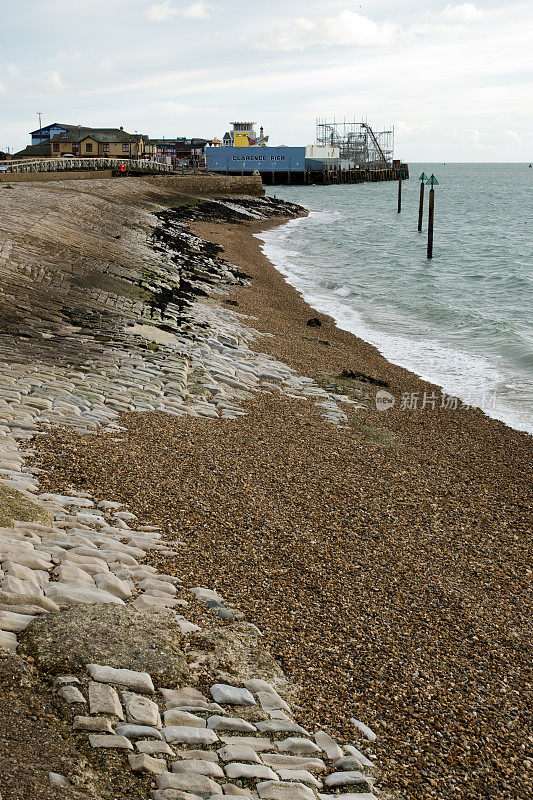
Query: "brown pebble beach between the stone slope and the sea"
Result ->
[[36, 212, 531, 800]]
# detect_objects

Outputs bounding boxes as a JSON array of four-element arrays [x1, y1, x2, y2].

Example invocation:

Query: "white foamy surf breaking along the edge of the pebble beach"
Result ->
[[256, 216, 533, 434]]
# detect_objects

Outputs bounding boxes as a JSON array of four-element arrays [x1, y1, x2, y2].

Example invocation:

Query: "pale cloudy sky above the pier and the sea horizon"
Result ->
[[0, 0, 533, 161]]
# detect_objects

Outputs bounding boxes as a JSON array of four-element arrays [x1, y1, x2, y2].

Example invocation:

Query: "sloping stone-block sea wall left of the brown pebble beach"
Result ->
[[0, 179, 382, 800]]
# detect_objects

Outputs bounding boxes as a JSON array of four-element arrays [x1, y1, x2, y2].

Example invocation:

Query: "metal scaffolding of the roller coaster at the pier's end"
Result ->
[[316, 118, 394, 167]]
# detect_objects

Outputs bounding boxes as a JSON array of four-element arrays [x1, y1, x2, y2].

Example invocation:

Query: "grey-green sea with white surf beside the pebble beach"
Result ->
[[258, 163, 533, 434]]
